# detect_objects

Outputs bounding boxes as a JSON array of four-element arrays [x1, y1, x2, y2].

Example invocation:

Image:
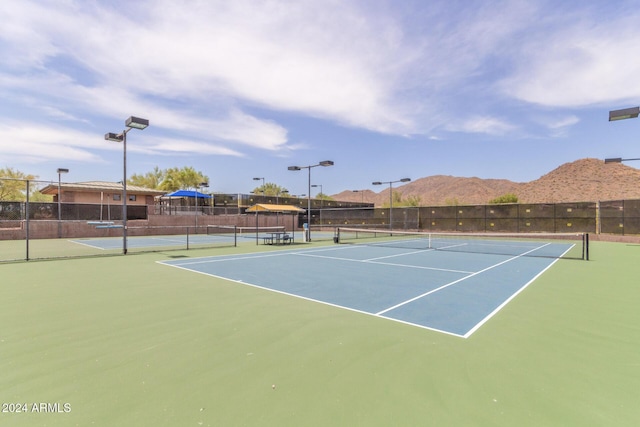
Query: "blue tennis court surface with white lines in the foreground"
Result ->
[[161, 243, 572, 338]]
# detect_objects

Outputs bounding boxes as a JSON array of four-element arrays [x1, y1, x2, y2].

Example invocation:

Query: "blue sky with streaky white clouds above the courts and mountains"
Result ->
[[0, 0, 640, 194]]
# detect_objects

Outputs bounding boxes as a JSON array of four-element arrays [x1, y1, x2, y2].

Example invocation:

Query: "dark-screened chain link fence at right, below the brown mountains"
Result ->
[[311, 200, 640, 235]]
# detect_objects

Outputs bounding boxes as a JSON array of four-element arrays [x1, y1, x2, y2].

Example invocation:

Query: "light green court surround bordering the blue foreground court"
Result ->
[[0, 242, 640, 427]]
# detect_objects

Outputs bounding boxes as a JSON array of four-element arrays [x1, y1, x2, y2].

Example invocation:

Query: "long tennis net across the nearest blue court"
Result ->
[[334, 227, 589, 260]]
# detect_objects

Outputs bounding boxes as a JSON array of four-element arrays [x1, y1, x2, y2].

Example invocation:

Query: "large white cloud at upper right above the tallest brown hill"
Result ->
[[501, 8, 640, 107]]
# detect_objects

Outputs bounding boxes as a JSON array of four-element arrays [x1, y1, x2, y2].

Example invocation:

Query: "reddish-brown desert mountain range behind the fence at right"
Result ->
[[332, 159, 640, 206]]
